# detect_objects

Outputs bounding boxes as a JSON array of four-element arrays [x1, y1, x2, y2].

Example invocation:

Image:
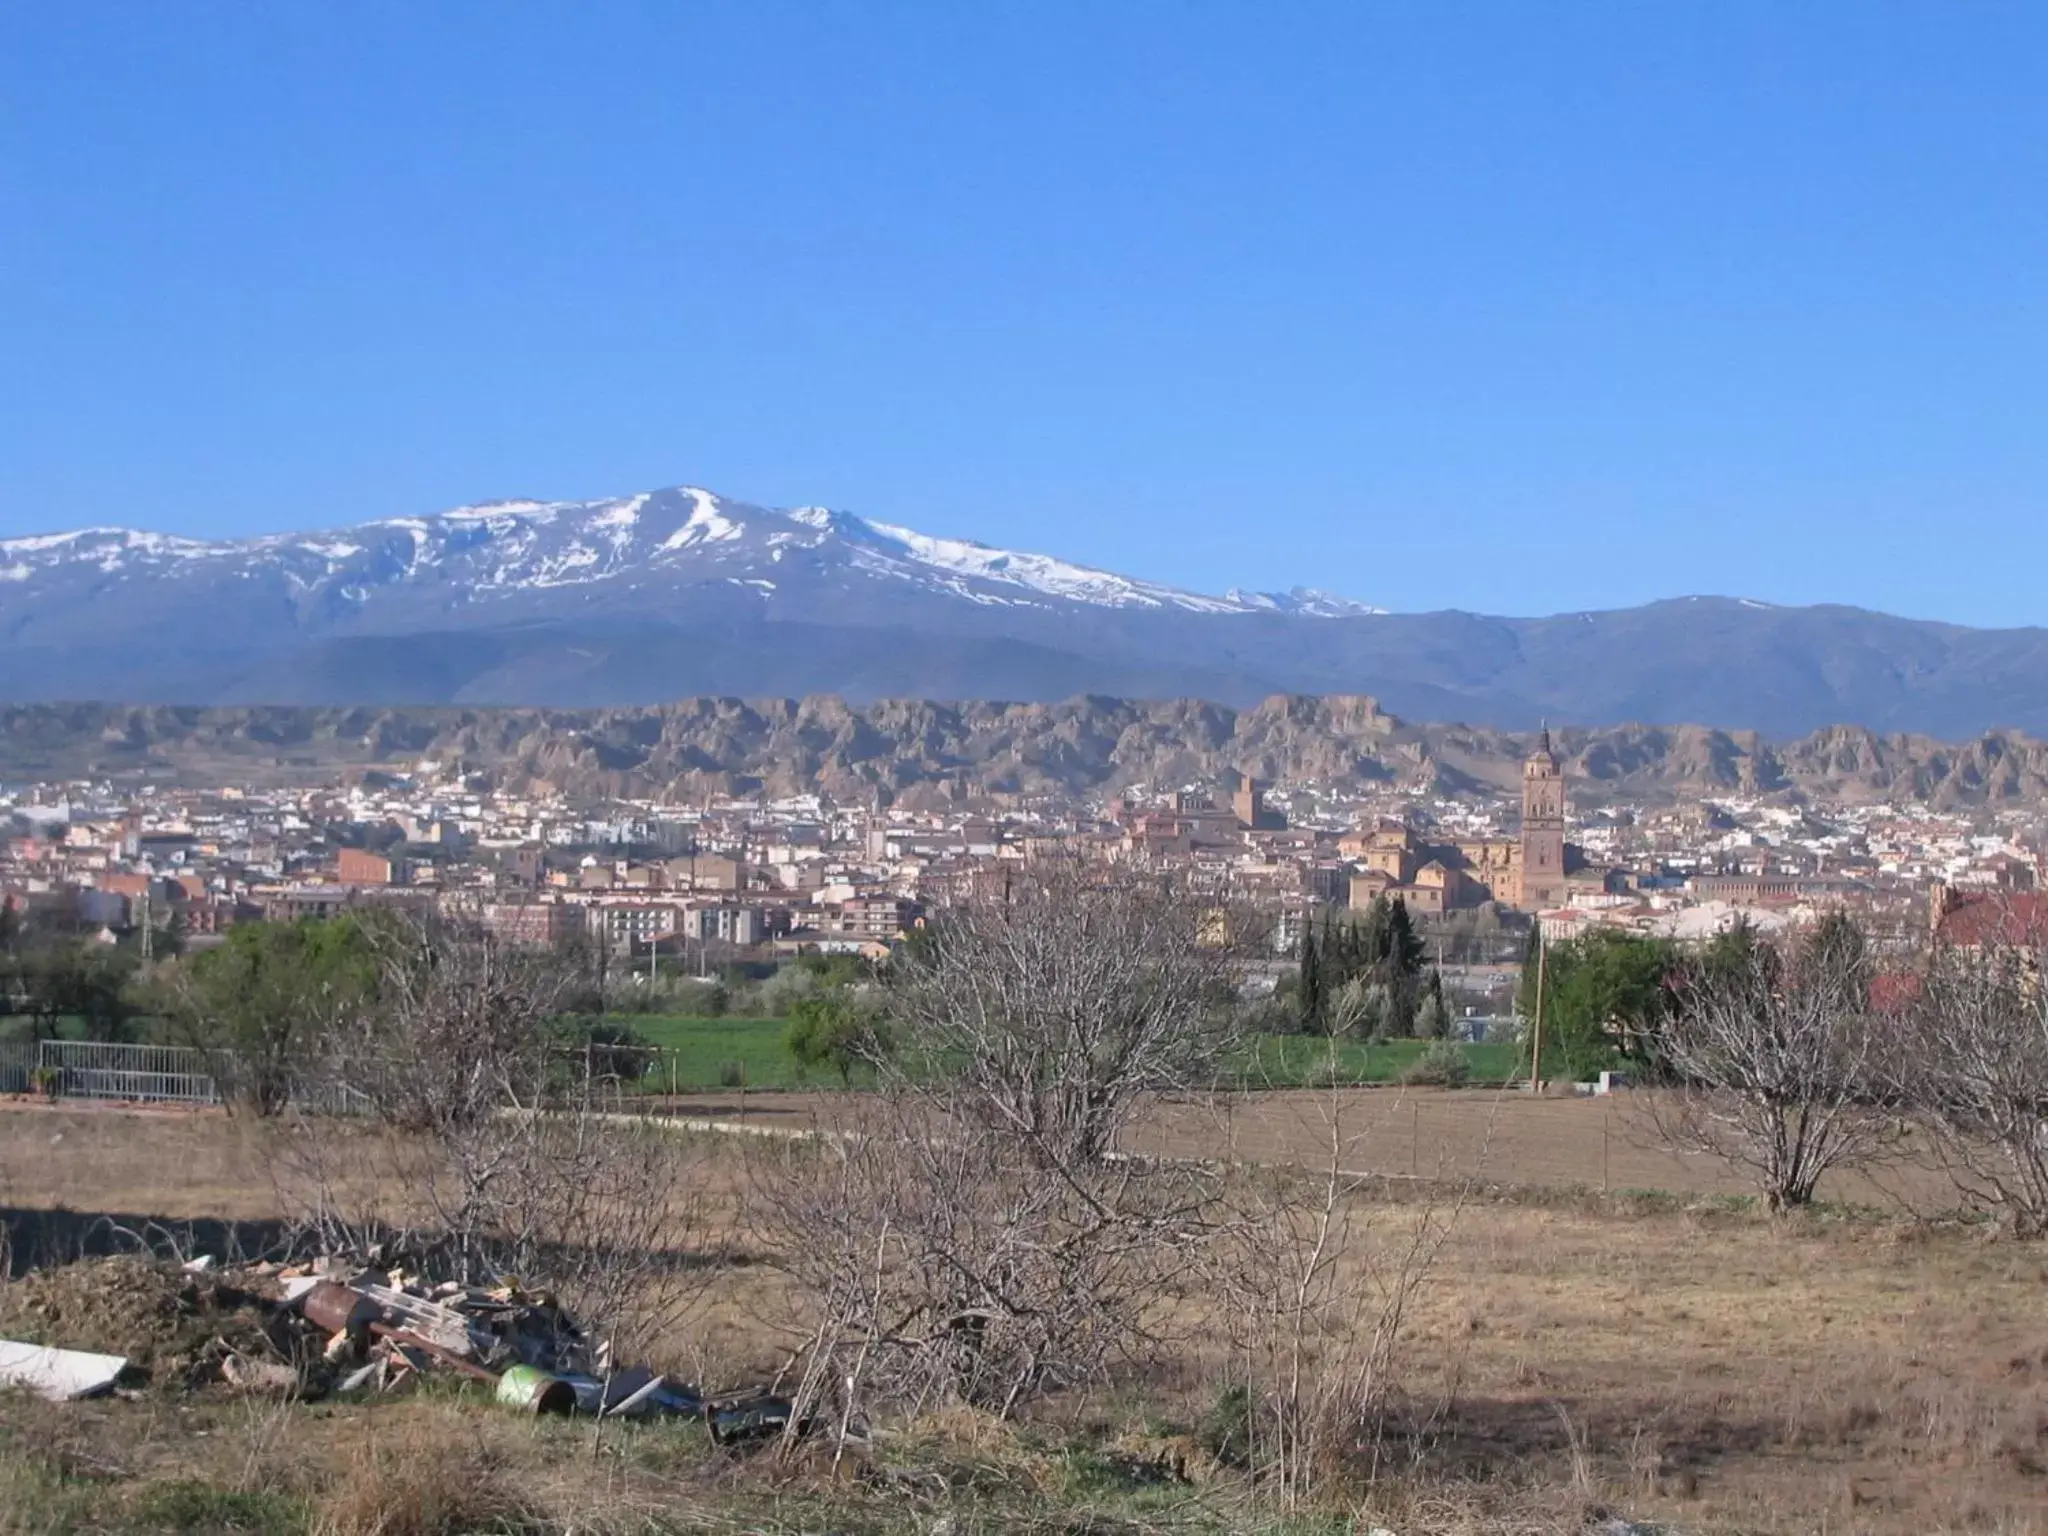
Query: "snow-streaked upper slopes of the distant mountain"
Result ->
[[0, 485, 1376, 627]]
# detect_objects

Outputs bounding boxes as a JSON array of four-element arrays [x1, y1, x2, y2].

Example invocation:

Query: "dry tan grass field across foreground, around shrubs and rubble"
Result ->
[[0, 1094, 2048, 1536]]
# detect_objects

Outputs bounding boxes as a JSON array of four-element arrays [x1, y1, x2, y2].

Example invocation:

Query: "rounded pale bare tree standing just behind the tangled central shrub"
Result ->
[[879, 858, 1255, 1167]]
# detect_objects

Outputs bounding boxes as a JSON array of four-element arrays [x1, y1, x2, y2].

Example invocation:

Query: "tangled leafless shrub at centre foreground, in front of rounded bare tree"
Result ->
[[758, 1096, 1217, 1415]]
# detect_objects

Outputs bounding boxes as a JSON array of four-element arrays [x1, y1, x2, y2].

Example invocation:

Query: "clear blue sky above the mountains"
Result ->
[[0, 0, 2048, 625]]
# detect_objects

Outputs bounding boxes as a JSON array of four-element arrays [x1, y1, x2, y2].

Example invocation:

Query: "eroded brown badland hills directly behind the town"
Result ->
[[0, 696, 2048, 809]]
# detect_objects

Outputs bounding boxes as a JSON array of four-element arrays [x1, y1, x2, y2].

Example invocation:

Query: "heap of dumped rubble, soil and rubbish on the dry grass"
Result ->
[[0, 1257, 791, 1444]]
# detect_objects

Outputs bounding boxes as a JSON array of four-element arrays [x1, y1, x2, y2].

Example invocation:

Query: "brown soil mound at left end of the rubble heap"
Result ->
[[0, 1257, 305, 1389]]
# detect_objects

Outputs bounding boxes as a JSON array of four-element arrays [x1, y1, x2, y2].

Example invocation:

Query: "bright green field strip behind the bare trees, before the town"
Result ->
[[610, 1014, 1518, 1092]]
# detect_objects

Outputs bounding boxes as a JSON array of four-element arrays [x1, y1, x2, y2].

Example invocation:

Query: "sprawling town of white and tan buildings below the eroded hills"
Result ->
[[12, 731, 2048, 974]]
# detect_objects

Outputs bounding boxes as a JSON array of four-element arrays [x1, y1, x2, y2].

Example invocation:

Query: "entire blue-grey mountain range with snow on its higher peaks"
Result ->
[[0, 487, 2048, 737]]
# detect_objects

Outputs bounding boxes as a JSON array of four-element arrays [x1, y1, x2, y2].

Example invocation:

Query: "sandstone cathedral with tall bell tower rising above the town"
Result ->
[[1337, 727, 1583, 913]]
